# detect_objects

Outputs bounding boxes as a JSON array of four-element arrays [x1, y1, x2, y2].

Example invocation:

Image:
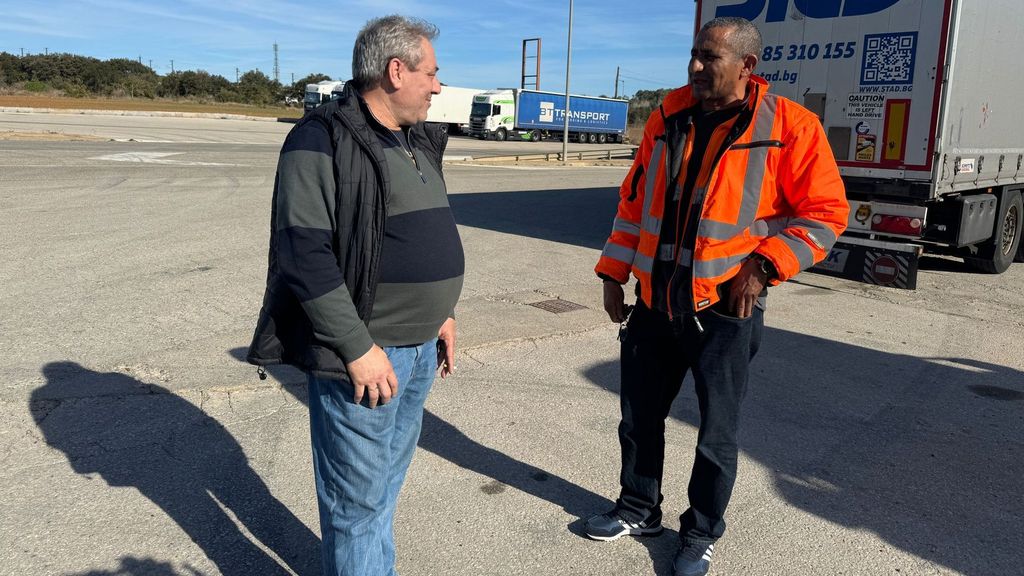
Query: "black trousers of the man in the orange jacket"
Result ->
[[616, 301, 764, 543]]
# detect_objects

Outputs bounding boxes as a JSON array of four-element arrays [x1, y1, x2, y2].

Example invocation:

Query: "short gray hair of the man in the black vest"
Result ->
[[352, 14, 439, 90]]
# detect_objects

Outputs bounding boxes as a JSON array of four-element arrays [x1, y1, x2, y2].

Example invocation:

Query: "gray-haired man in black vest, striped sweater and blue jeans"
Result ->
[[249, 15, 465, 576]]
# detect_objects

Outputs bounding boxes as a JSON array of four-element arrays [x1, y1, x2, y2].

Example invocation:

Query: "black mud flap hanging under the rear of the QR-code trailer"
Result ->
[[810, 237, 923, 290]]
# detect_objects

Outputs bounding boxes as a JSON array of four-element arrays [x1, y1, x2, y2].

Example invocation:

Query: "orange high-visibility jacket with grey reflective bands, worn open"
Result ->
[[595, 76, 850, 312]]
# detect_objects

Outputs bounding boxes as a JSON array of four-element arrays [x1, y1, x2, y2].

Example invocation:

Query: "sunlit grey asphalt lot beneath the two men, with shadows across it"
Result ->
[[0, 114, 1024, 576]]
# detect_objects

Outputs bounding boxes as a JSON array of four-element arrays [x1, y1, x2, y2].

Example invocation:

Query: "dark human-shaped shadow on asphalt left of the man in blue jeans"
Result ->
[[30, 362, 319, 576]]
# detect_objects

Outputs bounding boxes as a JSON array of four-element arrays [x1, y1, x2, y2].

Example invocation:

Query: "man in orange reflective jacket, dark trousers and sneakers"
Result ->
[[585, 17, 849, 576]]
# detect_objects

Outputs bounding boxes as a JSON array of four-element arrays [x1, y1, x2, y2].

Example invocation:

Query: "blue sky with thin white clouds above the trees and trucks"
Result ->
[[0, 0, 694, 95]]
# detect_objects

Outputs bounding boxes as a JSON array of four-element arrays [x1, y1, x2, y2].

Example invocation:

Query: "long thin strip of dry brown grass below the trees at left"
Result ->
[[0, 94, 302, 118]]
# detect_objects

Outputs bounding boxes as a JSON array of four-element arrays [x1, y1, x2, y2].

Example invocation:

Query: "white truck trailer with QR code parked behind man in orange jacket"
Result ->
[[696, 0, 1024, 288]]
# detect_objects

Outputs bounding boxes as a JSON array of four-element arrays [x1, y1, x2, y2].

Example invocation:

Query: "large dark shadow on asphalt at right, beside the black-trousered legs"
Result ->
[[585, 328, 1024, 576]]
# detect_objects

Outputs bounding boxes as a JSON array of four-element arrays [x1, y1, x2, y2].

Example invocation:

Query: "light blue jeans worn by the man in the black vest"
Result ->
[[307, 339, 437, 576]]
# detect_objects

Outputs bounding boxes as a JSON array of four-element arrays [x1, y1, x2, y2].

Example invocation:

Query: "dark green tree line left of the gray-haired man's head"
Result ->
[[0, 52, 330, 106]]
